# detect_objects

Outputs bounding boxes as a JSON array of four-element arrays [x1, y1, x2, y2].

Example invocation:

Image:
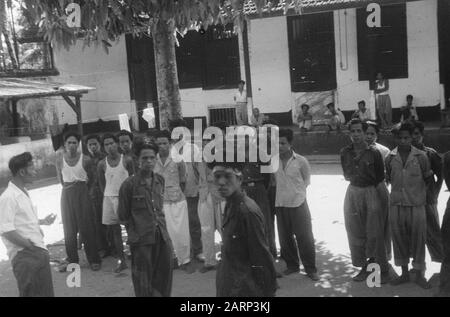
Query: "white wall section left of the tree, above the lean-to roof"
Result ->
[[54, 37, 135, 124]]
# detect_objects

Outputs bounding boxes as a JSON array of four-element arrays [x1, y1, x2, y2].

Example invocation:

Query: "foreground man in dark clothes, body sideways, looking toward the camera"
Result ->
[[211, 157, 277, 297]]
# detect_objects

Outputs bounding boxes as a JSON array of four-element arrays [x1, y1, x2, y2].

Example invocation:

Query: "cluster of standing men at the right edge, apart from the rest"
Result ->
[[341, 119, 450, 294]]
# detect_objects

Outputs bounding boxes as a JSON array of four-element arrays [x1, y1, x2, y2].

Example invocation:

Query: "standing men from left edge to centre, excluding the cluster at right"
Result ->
[[0, 115, 324, 296]]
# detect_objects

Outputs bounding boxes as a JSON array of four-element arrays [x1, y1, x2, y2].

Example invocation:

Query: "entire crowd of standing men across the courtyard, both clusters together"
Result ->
[[0, 119, 450, 297]]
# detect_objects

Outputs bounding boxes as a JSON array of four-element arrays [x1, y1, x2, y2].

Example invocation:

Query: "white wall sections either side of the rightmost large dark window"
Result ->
[[334, 0, 440, 110]]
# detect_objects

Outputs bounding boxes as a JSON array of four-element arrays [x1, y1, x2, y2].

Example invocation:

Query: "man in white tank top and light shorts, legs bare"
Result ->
[[98, 134, 133, 273]]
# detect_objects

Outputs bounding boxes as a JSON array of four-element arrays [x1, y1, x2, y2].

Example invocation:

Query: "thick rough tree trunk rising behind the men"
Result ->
[[153, 14, 182, 130]]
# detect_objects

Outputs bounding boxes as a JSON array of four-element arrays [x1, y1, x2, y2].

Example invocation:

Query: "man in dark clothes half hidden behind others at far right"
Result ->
[[412, 121, 444, 263]]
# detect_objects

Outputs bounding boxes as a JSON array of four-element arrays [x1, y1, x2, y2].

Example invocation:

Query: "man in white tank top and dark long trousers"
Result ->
[[56, 132, 101, 272]]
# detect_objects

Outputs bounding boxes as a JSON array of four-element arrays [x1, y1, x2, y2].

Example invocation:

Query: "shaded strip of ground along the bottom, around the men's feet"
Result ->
[[0, 242, 438, 297]]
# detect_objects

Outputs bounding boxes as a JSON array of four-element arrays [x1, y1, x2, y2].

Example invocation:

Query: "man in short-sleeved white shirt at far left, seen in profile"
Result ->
[[0, 152, 56, 297]]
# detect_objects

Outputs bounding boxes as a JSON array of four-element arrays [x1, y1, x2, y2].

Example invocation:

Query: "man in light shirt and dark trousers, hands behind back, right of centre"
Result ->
[[275, 129, 319, 281]]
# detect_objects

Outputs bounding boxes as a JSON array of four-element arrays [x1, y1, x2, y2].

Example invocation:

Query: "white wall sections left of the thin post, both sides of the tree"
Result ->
[[55, 30, 245, 124]]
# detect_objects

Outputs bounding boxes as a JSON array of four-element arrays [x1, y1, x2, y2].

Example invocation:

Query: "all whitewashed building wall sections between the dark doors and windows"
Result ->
[[51, 0, 440, 123]]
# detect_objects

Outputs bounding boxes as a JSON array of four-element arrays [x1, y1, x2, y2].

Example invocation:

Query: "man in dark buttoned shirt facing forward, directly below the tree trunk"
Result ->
[[118, 144, 173, 297]]
